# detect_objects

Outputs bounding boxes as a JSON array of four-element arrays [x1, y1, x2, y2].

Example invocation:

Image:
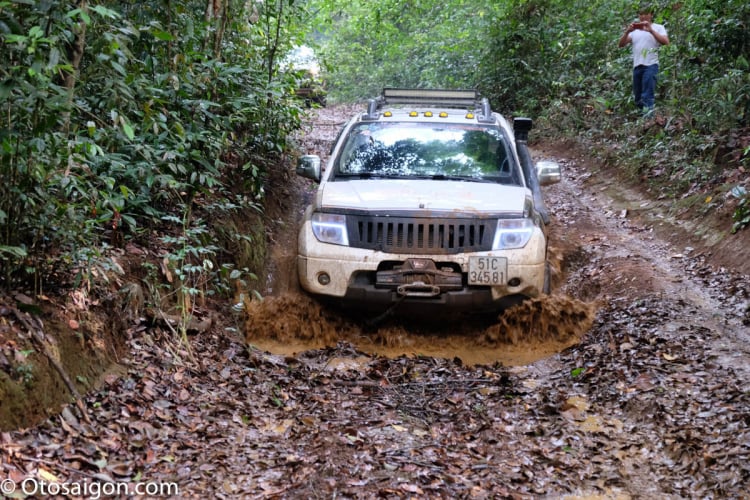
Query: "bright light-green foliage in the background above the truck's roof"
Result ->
[[314, 0, 496, 101]]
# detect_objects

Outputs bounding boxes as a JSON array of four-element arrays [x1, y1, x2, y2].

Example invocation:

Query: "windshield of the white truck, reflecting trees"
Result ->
[[335, 122, 521, 185]]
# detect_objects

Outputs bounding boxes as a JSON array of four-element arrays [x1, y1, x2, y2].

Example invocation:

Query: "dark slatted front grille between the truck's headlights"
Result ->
[[347, 215, 497, 255]]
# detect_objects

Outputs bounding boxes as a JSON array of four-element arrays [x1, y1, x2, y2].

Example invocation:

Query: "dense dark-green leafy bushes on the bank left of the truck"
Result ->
[[0, 0, 306, 291]]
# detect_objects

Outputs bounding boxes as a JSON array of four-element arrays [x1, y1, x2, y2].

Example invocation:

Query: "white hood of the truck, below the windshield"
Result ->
[[318, 179, 530, 214]]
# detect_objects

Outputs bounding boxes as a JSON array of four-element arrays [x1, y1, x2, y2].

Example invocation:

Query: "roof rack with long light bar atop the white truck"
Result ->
[[363, 87, 493, 122]]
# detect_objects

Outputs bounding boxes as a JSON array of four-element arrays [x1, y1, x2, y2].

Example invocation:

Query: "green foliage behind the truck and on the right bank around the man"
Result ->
[[315, 0, 750, 232]]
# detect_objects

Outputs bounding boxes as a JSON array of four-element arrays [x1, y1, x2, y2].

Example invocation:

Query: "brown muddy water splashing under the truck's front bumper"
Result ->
[[245, 294, 596, 366]]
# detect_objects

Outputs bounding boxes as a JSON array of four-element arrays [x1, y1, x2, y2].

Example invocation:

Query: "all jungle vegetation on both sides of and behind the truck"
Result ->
[[0, 0, 750, 305]]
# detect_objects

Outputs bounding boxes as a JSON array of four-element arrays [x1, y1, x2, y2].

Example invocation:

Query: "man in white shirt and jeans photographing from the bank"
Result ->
[[618, 7, 669, 115]]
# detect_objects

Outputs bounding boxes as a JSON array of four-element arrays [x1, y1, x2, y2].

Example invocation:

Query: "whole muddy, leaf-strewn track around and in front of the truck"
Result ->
[[0, 104, 750, 499]]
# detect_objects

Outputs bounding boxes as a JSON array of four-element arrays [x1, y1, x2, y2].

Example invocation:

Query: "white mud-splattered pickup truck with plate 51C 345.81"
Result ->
[[297, 88, 560, 314]]
